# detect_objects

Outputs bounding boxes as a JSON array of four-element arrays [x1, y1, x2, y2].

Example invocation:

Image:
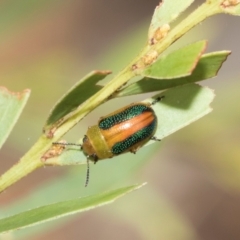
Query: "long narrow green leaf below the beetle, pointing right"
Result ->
[[0, 184, 145, 233]]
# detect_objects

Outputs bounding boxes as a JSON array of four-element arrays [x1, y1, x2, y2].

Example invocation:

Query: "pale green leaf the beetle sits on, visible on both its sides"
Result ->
[[45, 84, 214, 166]]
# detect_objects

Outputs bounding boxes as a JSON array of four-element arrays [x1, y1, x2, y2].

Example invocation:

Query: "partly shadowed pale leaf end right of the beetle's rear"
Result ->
[[151, 84, 215, 140]]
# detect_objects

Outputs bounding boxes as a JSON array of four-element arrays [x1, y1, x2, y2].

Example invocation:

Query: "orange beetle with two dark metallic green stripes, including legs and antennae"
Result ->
[[53, 96, 164, 186]]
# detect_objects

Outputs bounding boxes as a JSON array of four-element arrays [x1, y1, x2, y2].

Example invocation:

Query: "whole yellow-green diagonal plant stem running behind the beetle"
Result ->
[[0, 0, 225, 192]]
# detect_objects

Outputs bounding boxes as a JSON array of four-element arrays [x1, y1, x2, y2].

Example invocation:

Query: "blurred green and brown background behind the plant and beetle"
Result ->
[[0, 0, 240, 240]]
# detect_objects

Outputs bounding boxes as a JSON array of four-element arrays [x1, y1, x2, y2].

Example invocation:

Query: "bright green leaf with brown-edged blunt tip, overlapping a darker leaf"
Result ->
[[142, 40, 207, 79]]
